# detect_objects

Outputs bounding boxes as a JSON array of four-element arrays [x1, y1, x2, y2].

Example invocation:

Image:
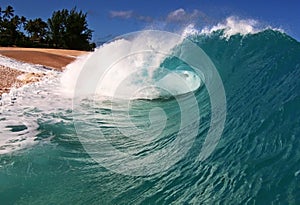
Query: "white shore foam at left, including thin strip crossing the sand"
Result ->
[[0, 56, 67, 154]]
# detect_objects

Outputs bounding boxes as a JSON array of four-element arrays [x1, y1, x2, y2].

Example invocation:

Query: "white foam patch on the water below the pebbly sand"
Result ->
[[0, 76, 72, 154]]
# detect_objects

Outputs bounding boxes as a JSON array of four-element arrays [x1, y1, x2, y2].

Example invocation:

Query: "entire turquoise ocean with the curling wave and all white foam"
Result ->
[[0, 19, 300, 204]]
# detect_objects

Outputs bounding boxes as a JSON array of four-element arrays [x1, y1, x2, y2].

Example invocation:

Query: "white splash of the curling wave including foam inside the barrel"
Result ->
[[62, 32, 204, 99]]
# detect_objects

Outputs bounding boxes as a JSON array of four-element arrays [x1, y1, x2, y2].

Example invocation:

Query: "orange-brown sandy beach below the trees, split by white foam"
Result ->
[[0, 47, 87, 96]]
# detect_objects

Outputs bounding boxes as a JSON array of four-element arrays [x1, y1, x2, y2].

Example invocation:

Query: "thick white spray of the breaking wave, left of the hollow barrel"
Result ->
[[61, 31, 186, 98]]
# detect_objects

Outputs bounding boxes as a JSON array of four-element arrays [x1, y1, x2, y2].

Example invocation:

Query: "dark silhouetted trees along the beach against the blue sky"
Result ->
[[0, 6, 96, 50]]
